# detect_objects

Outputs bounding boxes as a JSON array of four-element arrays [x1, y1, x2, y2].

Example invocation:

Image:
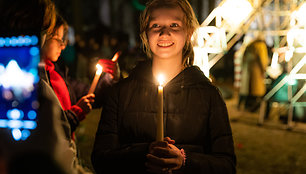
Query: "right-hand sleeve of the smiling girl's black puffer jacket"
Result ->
[[174, 87, 236, 174]]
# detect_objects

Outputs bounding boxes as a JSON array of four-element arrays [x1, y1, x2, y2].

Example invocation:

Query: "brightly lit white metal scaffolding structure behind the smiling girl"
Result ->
[[195, 0, 306, 128]]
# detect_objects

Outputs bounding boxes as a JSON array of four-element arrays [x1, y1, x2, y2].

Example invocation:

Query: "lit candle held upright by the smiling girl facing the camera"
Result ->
[[156, 75, 164, 141]]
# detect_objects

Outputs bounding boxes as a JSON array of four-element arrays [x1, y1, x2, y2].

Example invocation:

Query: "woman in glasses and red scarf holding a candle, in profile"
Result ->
[[42, 15, 95, 132]]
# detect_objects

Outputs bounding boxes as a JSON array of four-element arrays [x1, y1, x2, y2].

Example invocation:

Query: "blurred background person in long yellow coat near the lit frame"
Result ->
[[238, 36, 269, 112]]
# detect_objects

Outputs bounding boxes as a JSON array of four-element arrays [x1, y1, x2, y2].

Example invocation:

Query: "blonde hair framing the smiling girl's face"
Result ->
[[140, 0, 199, 67]]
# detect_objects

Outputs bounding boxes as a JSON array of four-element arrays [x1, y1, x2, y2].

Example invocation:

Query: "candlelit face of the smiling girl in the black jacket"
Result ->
[[147, 7, 187, 60]]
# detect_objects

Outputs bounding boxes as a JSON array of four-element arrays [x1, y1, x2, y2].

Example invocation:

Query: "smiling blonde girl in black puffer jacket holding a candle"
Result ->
[[92, 0, 236, 174]]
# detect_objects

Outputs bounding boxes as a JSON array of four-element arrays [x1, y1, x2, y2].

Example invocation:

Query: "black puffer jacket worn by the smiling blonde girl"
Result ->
[[92, 62, 236, 174]]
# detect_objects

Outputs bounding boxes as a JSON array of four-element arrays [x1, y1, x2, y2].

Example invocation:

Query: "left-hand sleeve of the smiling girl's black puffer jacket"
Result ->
[[91, 86, 149, 174]]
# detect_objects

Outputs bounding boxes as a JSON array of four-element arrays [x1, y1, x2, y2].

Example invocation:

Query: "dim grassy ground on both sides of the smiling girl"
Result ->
[[77, 92, 306, 174]]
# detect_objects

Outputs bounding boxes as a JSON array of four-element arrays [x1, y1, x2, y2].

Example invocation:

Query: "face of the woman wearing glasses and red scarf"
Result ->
[[42, 26, 65, 62]]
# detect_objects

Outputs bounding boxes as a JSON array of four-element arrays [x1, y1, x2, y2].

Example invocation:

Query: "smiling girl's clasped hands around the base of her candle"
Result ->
[[146, 137, 184, 173]]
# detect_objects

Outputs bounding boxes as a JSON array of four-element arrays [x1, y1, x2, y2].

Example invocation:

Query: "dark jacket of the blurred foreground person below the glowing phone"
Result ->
[[0, 65, 77, 174]]
